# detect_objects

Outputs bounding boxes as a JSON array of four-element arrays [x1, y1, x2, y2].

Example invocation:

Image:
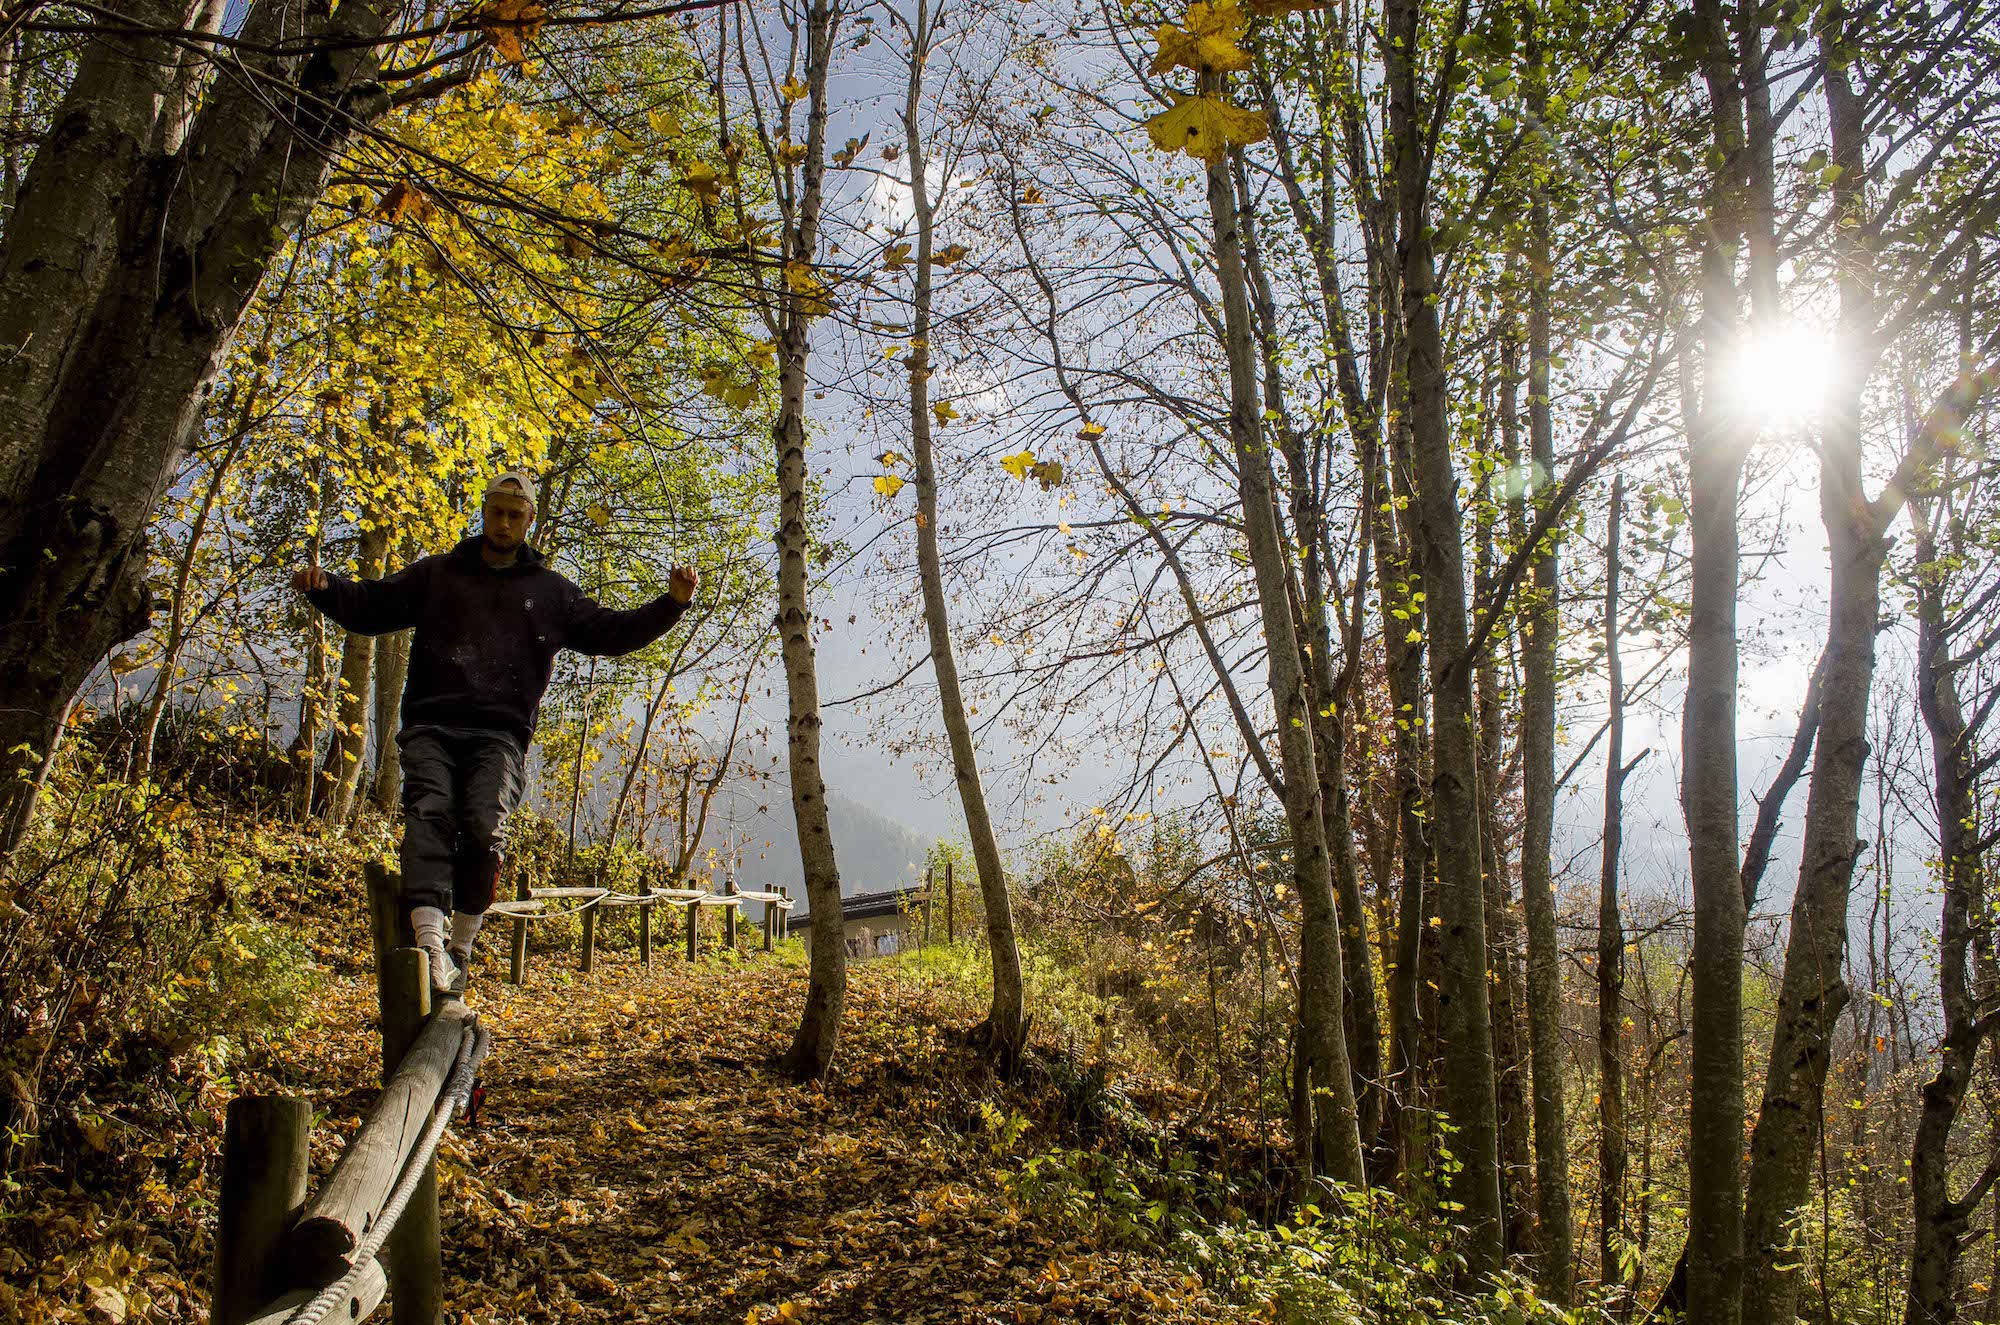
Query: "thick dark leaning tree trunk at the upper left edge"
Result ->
[[0, 0, 392, 857]]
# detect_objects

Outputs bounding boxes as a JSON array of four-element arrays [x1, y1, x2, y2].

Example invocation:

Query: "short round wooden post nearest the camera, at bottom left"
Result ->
[[208, 1095, 312, 1325]]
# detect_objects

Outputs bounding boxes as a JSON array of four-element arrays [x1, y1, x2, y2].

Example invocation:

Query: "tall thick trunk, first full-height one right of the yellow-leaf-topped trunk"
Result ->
[[1392, 0, 1506, 1283]]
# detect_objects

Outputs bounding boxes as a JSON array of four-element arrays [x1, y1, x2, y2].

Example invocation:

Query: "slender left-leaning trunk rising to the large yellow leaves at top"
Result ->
[[1208, 145, 1366, 1187]]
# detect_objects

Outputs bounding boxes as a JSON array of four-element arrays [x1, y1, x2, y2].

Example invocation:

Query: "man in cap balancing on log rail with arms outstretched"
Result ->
[[292, 470, 700, 995]]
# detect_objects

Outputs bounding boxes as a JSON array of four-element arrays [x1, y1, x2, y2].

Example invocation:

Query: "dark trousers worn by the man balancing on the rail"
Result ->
[[396, 727, 526, 915]]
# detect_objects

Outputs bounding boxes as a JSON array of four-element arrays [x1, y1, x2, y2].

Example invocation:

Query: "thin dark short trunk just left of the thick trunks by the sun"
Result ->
[[1598, 474, 1630, 1287]]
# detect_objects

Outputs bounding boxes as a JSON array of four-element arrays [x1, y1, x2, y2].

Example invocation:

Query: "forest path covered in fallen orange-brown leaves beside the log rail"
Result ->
[[294, 929, 1236, 1325]]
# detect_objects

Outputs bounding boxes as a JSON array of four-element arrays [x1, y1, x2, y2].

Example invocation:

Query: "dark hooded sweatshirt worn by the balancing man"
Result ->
[[306, 536, 686, 745]]
